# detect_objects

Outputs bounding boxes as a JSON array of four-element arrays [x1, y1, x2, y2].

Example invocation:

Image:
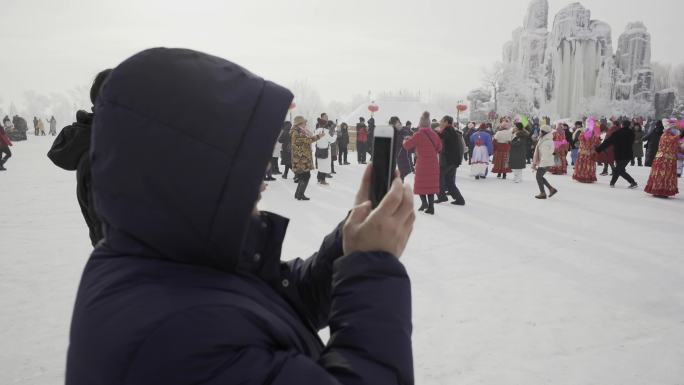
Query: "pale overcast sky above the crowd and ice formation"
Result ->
[[0, 0, 684, 106]]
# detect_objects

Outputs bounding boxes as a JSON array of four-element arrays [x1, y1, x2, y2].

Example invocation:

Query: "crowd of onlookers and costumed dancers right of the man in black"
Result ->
[[465, 117, 684, 199]]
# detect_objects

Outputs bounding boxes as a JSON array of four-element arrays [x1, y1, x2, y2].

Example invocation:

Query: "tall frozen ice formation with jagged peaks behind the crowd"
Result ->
[[503, 0, 654, 117]]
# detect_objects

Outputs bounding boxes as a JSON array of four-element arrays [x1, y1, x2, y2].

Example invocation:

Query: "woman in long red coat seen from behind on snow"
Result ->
[[404, 111, 442, 214]]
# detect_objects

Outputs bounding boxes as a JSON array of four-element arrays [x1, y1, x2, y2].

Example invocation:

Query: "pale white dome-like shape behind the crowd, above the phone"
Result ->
[[340, 96, 453, 127]]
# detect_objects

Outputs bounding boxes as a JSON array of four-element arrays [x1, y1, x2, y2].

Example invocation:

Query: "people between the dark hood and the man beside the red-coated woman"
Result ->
[[264, 112, 467, 214]]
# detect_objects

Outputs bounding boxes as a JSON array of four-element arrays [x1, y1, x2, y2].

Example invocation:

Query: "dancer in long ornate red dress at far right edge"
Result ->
[[644, 119, 680, 198]]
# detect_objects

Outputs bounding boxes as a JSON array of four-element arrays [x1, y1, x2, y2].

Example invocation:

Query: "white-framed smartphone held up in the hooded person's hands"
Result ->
[[370, 126, 397, 208]]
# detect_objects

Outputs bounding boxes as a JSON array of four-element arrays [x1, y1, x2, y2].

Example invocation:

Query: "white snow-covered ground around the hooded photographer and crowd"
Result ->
[[0, 136, 684, 385]]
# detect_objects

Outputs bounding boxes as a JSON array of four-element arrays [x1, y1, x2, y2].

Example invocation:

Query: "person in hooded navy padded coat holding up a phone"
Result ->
[[65, 48, 415, 385]]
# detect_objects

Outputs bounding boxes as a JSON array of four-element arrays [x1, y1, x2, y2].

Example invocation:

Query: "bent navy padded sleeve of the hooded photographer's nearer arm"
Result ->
[[121, 252, 414, 385]]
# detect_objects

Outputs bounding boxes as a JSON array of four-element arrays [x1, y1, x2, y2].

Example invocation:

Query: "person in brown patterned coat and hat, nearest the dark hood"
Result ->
[[290, 116, 323, 201]]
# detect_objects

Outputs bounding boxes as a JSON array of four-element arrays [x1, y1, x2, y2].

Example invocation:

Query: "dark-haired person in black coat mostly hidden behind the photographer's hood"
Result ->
[[47, 69, 112, 246]]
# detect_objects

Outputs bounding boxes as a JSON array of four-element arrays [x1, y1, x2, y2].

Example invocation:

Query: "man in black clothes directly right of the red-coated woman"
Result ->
[[435, 115, 465, 206]]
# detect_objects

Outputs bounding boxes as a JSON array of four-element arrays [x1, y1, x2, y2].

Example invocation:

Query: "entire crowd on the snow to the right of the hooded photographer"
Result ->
[[258, 112, 684, 208]]
